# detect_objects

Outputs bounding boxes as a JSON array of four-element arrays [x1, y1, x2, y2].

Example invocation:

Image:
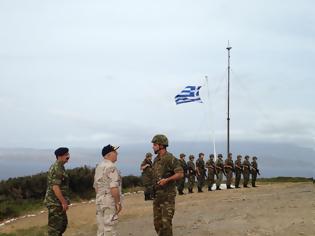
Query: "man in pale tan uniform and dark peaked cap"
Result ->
[[93, 144, 122, 236]]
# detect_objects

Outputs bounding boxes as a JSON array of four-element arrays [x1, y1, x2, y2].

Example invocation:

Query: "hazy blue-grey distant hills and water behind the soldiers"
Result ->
[[0, 142, 315, 179]]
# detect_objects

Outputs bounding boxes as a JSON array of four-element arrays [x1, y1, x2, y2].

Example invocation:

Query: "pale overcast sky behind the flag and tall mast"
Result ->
[[0, 0, 315, 149]]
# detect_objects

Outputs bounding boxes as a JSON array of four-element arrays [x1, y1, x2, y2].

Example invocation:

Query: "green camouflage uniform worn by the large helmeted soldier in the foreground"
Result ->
[[153, 152, 183, 236]]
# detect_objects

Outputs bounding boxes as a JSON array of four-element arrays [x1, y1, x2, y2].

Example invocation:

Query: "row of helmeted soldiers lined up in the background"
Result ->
[[140, 153, 260, 200]]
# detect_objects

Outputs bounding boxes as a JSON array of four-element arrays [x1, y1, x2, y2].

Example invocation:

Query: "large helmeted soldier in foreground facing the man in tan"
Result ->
[[151, 134, 184, 236]]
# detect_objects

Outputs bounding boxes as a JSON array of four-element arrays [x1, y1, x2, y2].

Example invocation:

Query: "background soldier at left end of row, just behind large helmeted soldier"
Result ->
[[140, 152, 153, 201]]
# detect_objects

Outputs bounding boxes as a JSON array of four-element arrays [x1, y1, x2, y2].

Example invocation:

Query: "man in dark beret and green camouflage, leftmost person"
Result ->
[[44, 147, 70, 236]]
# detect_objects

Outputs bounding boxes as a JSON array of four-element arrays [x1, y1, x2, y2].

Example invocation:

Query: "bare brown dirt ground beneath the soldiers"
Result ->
[[0, 183, 315, 236]]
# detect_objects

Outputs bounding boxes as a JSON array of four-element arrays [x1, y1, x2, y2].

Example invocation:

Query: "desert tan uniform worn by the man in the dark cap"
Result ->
[[93, 159, 121, 236]]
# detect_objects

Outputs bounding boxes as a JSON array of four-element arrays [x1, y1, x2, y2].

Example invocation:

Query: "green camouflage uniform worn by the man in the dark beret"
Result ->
[[44, 161, 70, 236]]
